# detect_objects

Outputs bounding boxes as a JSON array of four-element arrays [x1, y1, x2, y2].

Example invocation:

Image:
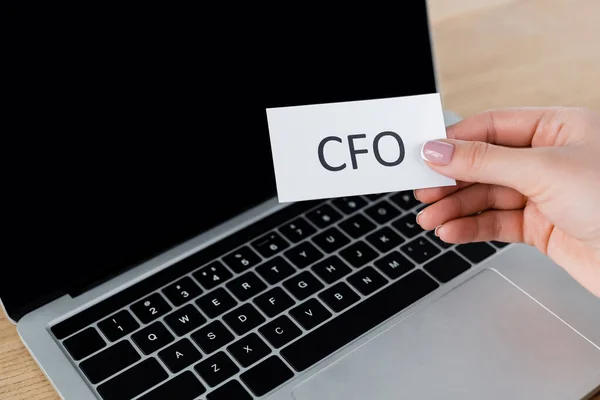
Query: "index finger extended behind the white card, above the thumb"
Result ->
[[446, 107, 560, 147]]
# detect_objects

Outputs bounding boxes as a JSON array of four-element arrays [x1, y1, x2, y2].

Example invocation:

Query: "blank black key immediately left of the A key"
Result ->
[[98, 357, 169, 400]]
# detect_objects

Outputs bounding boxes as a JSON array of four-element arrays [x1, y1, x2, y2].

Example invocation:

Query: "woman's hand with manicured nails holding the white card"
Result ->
[[415, 108, 600, 296]]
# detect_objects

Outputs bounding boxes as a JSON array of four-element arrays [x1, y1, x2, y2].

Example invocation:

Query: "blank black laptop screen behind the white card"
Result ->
[[0, 1, 436, 318]]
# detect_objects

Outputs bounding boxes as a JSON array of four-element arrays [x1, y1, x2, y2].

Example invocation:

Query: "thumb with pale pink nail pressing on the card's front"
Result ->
[[421, 139, 551, 196]]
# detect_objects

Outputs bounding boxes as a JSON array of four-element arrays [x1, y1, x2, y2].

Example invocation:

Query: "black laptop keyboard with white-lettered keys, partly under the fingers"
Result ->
[[51, 192, 505, 400]]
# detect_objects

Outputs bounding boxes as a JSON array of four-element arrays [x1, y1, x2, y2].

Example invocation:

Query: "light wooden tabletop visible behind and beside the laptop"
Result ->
[[0, 0, 600, 400]]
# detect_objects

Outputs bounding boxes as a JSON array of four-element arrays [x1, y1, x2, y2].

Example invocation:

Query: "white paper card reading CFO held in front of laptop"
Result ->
[[266, 93, 456, 202]]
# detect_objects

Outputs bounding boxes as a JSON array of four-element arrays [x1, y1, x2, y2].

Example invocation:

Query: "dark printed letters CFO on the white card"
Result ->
[[317, 131, 405, 172]]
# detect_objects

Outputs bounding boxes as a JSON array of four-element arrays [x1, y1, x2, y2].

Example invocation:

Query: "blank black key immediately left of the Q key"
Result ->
[[79, 340, 141, 384]]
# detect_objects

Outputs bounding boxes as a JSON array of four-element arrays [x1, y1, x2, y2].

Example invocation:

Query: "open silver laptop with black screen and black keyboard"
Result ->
[[0, 1, 600, 400]]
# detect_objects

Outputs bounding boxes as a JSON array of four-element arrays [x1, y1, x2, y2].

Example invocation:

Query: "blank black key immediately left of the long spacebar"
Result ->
[[240, 356, 294, 396]]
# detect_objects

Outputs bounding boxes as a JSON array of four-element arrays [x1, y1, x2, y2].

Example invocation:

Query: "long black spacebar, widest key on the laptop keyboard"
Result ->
[[281, 270, 439, 371]]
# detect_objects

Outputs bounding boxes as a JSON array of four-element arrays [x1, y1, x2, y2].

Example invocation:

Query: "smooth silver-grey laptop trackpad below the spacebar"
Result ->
[[293, 270, 600, 400]]
